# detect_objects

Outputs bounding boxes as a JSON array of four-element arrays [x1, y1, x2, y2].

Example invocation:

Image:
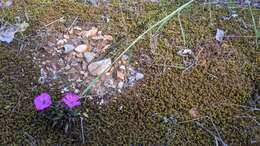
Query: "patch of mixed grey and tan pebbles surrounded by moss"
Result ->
[[35, 26, 144, 100]]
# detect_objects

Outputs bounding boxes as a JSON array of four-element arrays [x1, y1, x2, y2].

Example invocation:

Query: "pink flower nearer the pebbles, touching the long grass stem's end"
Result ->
[[62, 92, 80, 108]]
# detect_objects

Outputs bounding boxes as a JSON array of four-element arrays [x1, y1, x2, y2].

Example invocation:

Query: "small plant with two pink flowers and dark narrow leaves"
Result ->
[[34, 92, 80, 133]]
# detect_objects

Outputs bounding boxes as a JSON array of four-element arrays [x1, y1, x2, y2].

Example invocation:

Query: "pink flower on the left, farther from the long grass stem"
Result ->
[[34, 93, 52, 111]]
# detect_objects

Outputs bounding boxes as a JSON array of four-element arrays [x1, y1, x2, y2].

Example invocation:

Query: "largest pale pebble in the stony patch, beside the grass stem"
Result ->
[[88, 58, 112, 76]]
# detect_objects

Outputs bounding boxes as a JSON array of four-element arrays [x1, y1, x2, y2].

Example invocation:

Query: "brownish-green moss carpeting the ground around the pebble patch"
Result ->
[[0, 0, 260, 145]]
